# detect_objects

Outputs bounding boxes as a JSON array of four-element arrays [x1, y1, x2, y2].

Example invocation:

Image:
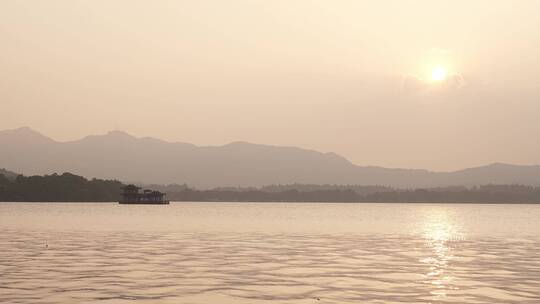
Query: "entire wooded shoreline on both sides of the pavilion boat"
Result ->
[[0, 173, 540, 203]]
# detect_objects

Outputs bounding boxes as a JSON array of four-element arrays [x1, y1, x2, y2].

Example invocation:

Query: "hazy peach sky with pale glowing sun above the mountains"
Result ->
[[0, 0, 540, 170]]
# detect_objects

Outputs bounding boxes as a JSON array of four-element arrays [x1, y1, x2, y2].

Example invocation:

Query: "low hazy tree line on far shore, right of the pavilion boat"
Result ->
[[168, 185, 540, 203]]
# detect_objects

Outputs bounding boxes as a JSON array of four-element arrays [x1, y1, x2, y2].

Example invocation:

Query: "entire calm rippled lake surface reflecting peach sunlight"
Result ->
[[0, 203, 540, 303]]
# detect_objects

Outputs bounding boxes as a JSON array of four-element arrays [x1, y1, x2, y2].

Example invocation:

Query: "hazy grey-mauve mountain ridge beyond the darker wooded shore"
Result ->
[[0, 127, 540, 189]]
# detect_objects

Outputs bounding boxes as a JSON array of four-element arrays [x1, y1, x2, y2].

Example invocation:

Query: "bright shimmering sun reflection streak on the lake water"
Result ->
[[420, 208, 463, 300]]
